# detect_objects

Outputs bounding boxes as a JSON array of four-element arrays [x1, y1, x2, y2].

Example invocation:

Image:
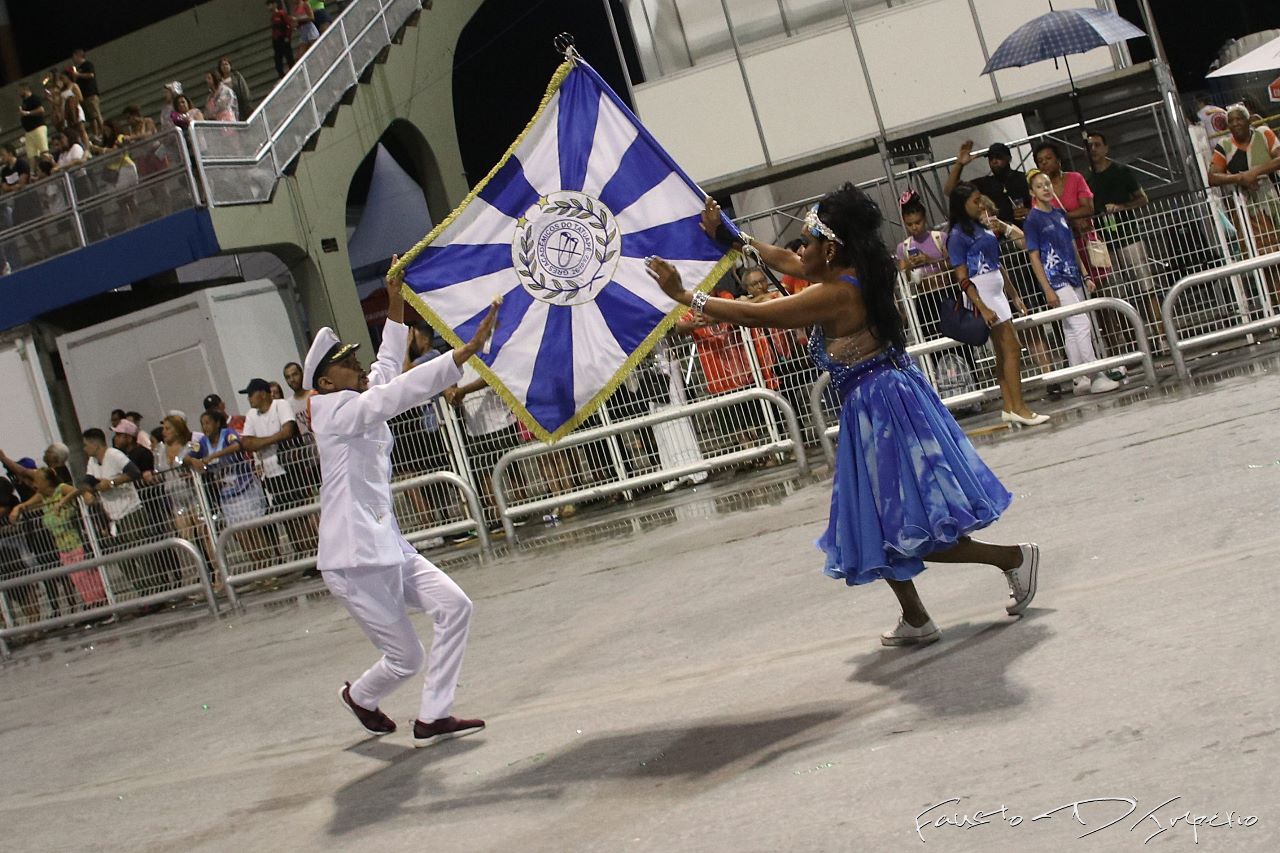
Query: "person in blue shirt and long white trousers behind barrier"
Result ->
[[1023, 172, 1120, 394]]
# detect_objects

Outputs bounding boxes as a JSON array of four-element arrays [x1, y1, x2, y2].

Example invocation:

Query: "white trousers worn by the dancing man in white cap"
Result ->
[[323, 555, 471, 722]]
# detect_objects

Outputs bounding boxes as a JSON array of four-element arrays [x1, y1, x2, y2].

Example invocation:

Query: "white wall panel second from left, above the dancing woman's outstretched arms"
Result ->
[[745, 28, 876, 163]]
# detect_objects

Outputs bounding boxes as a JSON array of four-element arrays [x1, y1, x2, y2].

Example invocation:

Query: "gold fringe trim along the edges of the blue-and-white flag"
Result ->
[[388, 60, 739, 444]]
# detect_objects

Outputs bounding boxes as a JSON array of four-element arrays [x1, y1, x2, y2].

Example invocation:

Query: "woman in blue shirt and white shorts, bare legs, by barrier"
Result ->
[[947, 183, 1048, 427]]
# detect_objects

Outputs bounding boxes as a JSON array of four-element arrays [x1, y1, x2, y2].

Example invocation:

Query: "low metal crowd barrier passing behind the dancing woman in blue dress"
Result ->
[[809, 294, 1162, 465]]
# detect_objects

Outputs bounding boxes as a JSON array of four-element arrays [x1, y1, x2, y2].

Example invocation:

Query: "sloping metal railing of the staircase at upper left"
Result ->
[[191, 0, 422, 206]]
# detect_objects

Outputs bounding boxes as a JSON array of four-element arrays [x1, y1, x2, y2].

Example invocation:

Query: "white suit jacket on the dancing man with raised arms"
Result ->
[[311, 320, 462, 571]]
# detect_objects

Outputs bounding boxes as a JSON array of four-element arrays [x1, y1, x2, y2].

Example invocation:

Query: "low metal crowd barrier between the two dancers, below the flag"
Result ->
[[493, 388, 809, 542]]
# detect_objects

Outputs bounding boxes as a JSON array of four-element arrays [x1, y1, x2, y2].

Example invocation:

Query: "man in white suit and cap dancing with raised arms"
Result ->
[[303, 258, 498, 747]]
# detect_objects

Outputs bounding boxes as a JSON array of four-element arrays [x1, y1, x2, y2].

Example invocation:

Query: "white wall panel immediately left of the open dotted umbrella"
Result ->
[[858, 0, 995, 131]]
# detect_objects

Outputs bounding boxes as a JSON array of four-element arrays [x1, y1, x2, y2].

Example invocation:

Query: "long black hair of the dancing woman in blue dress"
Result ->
[[818, 183, 906, 350]]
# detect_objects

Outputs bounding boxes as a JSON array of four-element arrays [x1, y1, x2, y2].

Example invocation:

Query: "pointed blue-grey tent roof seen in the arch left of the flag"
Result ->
[[347, 142, 431, 298]]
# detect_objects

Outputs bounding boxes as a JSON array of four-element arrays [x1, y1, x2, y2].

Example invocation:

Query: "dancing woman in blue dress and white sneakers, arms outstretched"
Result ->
[[648, 183, 1039, 646]]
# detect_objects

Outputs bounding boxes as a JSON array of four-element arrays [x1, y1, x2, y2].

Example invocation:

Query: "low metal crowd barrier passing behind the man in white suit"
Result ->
[[216, 471, 492, 610]]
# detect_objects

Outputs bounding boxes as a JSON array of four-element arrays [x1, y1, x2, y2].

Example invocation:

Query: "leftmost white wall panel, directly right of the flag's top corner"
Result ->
[[636, 61, 764, 182]]
